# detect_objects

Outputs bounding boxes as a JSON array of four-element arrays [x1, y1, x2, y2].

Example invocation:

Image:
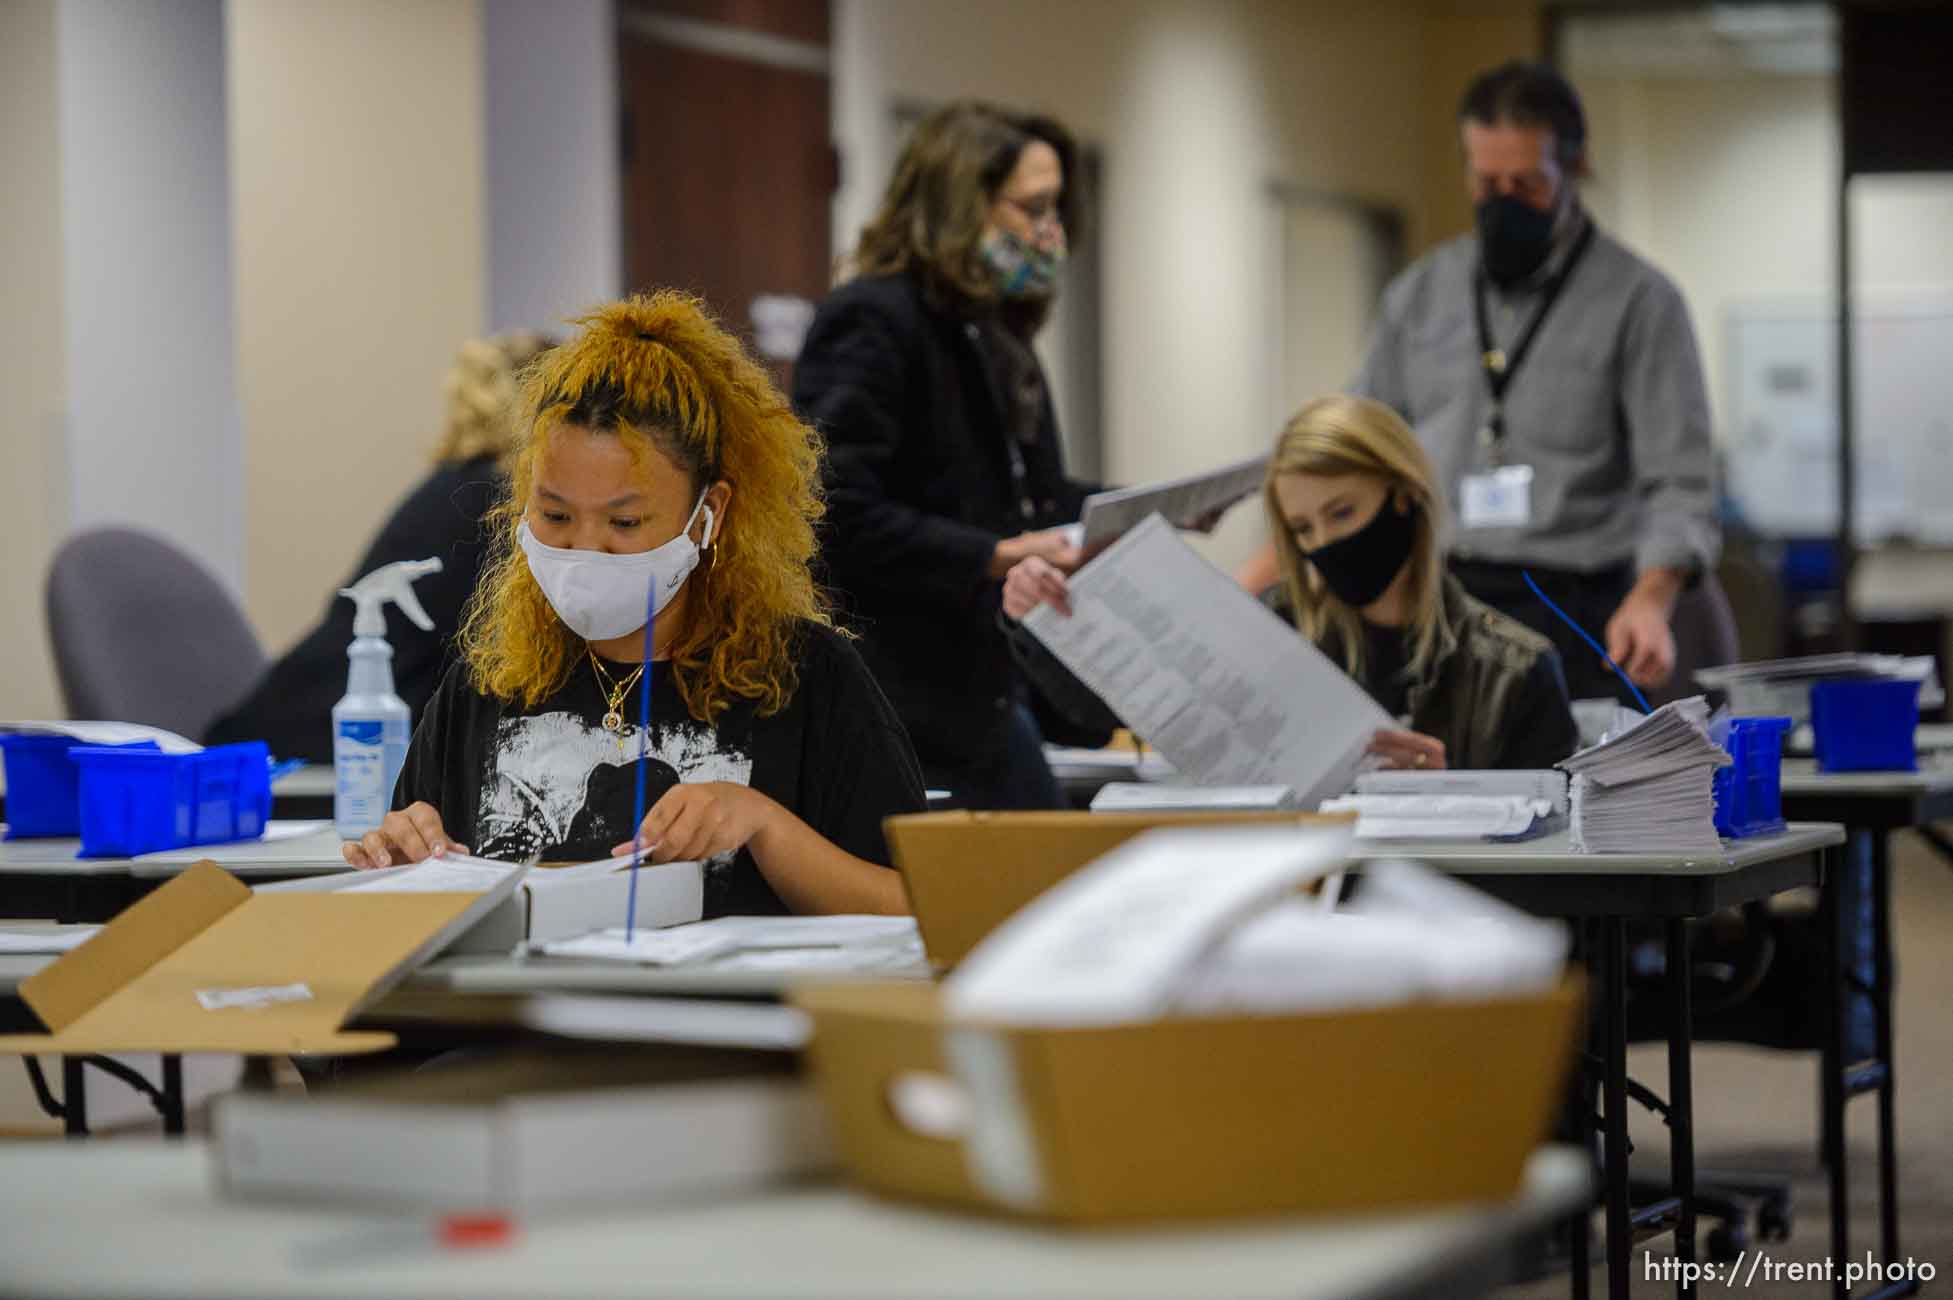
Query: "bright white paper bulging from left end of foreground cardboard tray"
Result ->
[[943, 824, 1350, 1025]]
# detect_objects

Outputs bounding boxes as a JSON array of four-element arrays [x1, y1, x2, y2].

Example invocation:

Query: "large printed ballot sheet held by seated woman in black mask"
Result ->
[[1023, 515, 1394, 806]]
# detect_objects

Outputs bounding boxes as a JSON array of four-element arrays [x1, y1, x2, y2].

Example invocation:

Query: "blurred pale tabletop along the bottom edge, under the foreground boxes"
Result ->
[[0, 1140, 1588, 1300]]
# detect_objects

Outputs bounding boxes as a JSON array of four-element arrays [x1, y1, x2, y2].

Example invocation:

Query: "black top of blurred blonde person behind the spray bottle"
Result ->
[[205, 459, 500, 763]]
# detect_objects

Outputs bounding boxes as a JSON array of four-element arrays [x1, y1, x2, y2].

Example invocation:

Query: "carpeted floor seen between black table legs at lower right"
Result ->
[[1498, 835, 1953, 1300]]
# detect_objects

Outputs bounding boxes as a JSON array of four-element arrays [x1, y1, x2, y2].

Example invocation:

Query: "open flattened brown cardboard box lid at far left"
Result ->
[[0, 863, 521, 1056]]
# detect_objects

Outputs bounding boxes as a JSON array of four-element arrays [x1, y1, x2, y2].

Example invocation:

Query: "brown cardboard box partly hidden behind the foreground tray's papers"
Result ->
[[883, 812, 1353, 968]]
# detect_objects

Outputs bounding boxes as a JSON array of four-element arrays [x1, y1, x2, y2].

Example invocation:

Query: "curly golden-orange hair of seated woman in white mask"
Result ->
[[461, 289, 830, 722]]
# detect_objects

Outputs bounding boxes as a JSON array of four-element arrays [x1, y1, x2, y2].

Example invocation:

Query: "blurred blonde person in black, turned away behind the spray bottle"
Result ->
[[203, 330, 555, 763]]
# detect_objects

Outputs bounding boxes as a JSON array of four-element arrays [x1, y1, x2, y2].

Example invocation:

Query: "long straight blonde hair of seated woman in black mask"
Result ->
[[1262, 394, 1443, 679]]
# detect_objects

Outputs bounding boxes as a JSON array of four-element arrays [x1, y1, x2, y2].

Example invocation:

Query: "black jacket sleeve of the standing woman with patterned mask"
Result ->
[[793, 291, 998, 611]]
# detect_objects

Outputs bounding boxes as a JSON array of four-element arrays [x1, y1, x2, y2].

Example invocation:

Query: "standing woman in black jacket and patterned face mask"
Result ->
[[793, 102, 1094, 808]]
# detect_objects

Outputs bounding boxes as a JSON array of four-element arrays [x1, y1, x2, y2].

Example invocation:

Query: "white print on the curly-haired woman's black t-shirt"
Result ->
[[475, 712, 752, 865]]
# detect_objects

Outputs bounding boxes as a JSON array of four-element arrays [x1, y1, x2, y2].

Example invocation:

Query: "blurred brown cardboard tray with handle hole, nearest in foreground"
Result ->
[[793, 976, 1582, 1226]]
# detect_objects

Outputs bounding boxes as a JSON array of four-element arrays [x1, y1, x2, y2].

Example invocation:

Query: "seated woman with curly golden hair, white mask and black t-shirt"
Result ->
[[346, 293, 924, 915]]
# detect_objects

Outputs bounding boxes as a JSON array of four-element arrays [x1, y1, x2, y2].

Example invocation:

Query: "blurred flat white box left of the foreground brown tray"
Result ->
[[211, 1042, 836, 1212]]
